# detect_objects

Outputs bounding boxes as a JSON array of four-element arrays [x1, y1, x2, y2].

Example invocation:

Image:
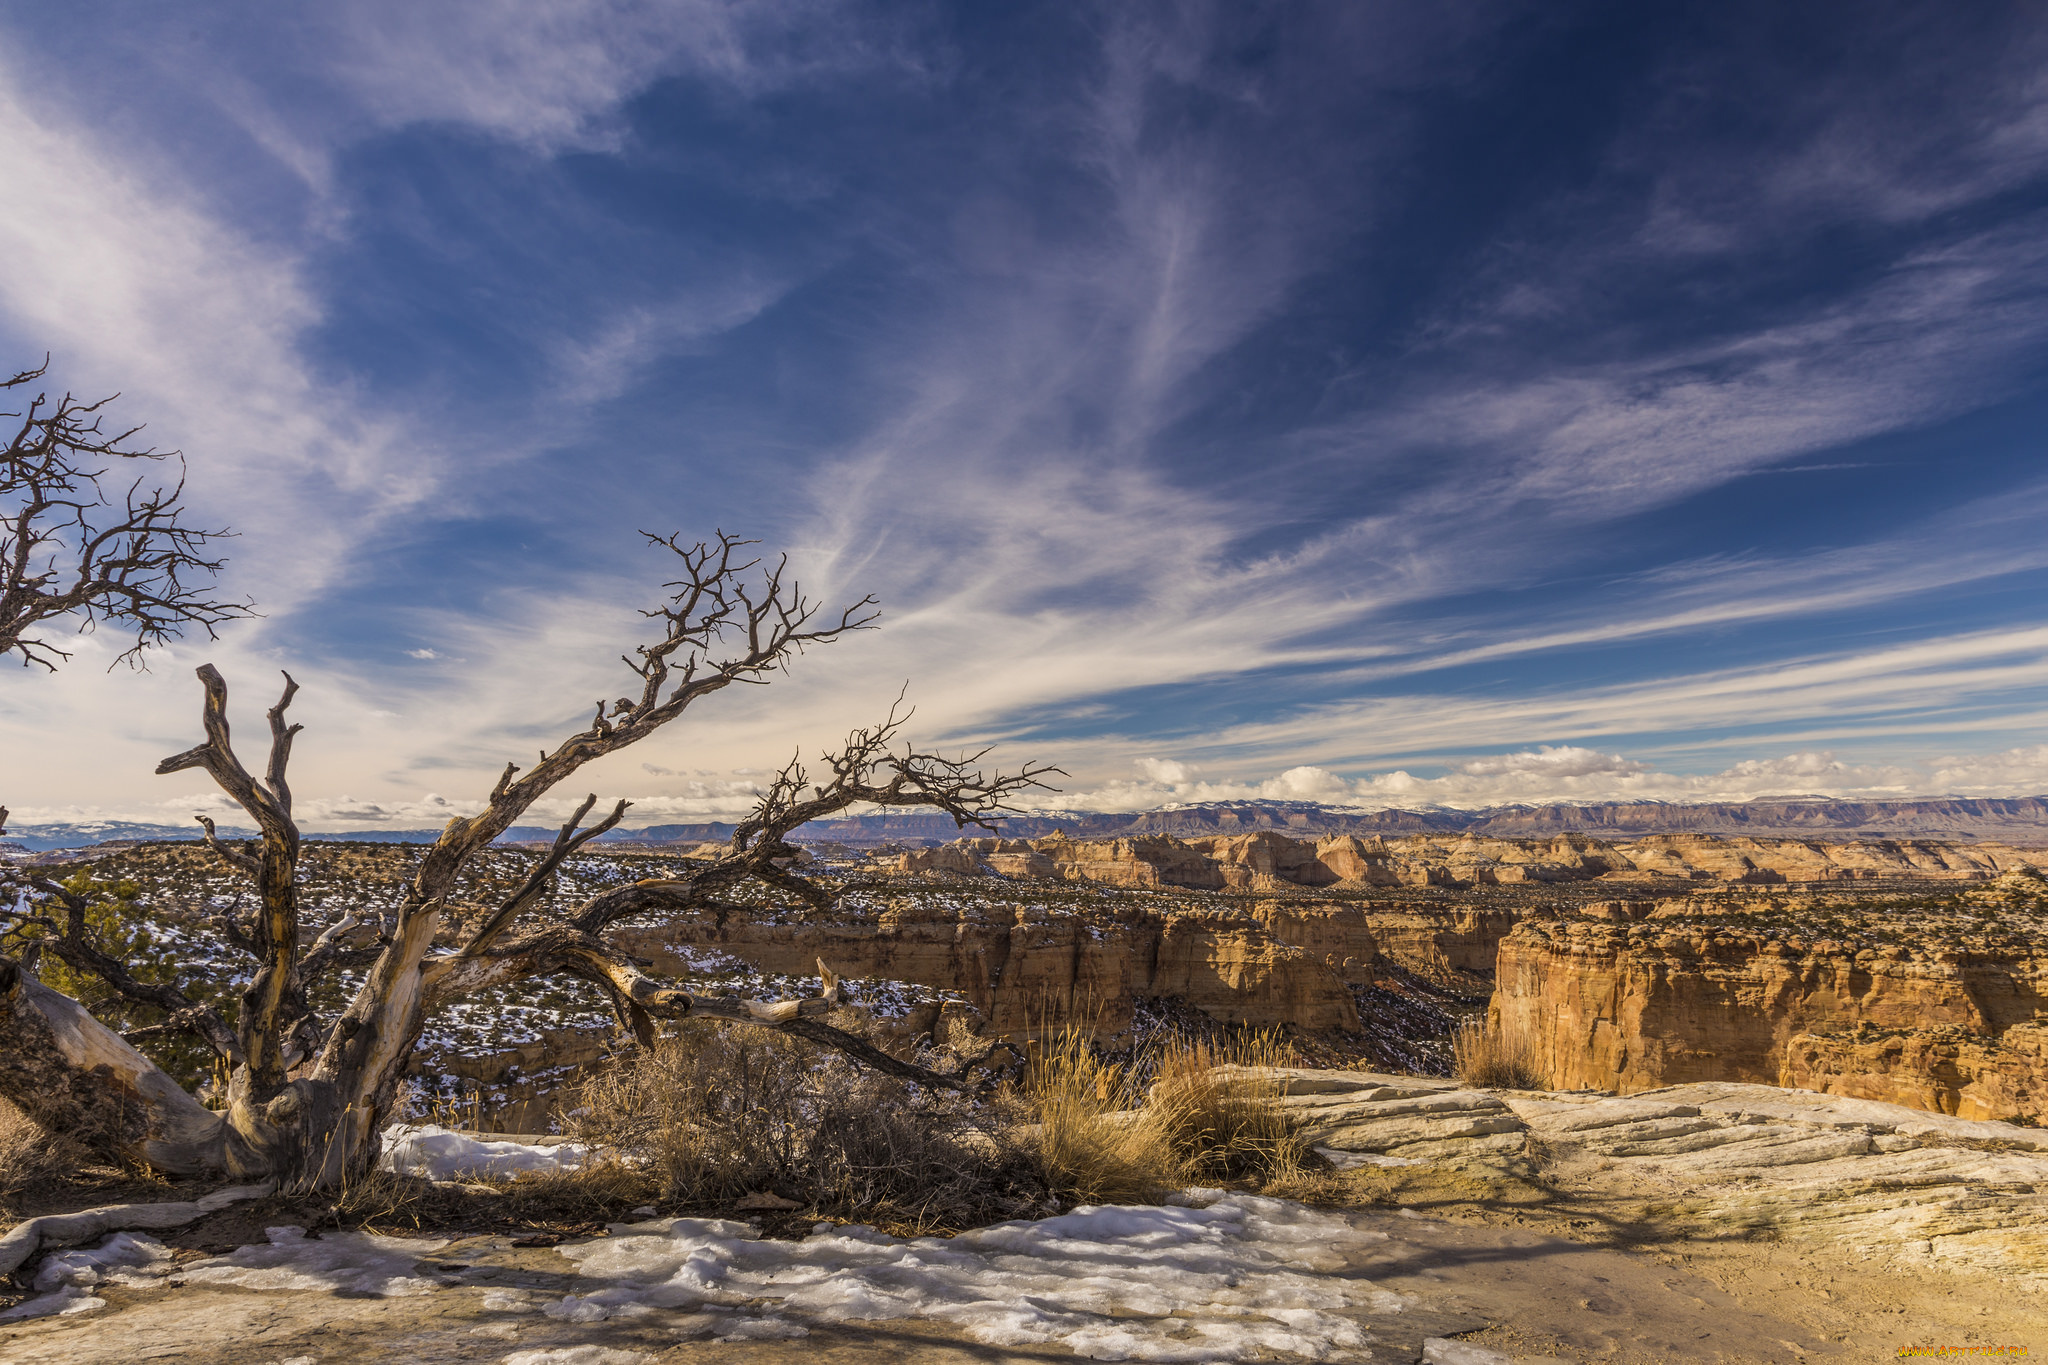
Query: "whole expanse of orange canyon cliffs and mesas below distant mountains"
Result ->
[[428, 831, 2048, 1124]]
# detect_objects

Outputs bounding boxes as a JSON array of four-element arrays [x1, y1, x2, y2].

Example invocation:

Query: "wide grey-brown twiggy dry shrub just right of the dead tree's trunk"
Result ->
[[567, 1021, 1044, 1232]]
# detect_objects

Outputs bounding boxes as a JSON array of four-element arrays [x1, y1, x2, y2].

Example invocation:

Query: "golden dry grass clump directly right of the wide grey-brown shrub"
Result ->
[[1024, 1025, 1188, 1203]]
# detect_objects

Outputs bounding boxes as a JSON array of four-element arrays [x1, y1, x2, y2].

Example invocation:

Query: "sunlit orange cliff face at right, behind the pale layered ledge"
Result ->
[[1491, 902, 2048, 1121]]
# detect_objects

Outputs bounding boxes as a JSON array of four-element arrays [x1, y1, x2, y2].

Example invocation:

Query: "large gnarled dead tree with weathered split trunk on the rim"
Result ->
[[0, 532, 1053, 1189]]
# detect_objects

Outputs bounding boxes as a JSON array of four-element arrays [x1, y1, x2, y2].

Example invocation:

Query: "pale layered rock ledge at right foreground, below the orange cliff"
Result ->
[[1266, 1070, 2048, 1291]]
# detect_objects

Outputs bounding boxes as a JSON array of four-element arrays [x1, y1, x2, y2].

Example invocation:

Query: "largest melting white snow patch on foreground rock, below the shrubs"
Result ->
[[547, 1195, 1409, 1363]]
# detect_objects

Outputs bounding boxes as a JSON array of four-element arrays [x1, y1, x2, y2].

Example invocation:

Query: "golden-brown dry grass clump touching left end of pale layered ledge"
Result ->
[[1149, 1029, 1307, 1183]]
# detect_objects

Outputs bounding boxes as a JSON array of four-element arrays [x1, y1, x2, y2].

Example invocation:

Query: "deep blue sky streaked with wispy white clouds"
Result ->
[[0, 0, 2048, 827]]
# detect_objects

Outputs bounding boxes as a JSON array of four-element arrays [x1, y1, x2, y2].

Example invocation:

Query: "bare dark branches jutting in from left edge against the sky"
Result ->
[[0, 362, 250, 669]]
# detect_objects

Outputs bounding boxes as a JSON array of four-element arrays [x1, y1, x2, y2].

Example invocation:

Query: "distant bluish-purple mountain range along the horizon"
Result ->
[[16, 796, 2048, 851]]
